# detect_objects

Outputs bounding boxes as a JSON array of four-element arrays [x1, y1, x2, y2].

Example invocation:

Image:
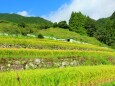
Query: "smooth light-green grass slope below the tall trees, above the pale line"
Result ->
[[38, 28, 106, 46]]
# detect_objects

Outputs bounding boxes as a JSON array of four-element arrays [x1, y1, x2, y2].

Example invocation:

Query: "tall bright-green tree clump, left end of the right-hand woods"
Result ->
[[69, 12, 86, 35]]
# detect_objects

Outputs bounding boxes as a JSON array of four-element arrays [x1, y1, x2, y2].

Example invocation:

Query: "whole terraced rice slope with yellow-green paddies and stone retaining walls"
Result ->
[[0, 36, 115, 86]]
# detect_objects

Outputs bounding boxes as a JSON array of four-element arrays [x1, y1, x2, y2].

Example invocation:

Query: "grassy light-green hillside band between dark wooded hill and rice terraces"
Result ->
[[0, 18, 107, 47]]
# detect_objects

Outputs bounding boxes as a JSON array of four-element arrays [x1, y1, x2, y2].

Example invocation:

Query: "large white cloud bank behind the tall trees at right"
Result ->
[[44, 0, 115, 22]]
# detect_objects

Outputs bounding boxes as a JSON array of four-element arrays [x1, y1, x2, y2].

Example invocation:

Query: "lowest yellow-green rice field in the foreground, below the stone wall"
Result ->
[[0, 65, 115, 86]]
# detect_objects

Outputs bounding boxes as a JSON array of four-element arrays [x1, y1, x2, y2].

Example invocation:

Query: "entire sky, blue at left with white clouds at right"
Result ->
[[0, 0, 115, 22]]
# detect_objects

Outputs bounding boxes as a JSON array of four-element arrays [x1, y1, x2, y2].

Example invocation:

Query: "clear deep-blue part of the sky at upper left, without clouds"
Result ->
[[0, 0, 71, 16]]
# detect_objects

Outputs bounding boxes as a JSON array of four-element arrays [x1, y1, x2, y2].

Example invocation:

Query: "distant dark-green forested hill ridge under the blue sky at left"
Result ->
[[0, 13, 52, 24]]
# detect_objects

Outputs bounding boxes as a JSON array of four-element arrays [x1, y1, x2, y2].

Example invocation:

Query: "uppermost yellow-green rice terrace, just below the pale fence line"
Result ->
[[0, 37, 114, 51]]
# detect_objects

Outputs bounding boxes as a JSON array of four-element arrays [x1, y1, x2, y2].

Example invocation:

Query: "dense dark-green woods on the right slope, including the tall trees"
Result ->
[[69, 12, 115, 47]]
